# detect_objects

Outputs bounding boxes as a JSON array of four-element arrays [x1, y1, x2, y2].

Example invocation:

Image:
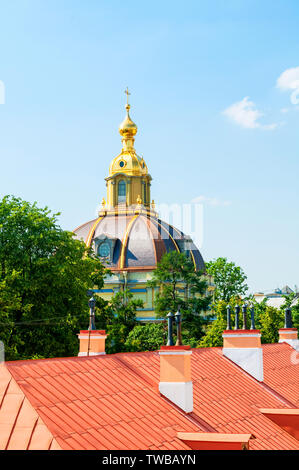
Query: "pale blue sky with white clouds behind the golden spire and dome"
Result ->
[[0, 0, 299, 290]]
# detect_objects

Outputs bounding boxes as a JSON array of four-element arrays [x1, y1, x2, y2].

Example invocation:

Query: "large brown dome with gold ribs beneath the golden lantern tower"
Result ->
[[74, 213, 205, 271]]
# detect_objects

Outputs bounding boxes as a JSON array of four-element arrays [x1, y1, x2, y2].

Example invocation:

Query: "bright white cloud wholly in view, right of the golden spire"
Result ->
[[223, 96, 277, 130]]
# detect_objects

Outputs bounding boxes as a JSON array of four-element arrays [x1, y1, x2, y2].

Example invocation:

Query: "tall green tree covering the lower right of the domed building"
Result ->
[[148, 251, 211, 345]]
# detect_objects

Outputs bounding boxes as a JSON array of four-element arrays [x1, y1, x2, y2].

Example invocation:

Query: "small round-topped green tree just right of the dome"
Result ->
[[206, 258, 248, 302]]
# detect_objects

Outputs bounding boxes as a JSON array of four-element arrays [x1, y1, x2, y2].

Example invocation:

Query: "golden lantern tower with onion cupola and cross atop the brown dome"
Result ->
[[105, 88, 151, 210]]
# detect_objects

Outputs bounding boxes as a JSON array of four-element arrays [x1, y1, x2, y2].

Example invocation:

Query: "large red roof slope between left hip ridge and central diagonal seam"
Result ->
[[7, 353, 199, 450]]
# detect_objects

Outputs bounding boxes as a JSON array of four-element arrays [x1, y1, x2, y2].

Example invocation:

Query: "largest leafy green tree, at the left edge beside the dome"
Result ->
[[0, 196, 106, 360]]
